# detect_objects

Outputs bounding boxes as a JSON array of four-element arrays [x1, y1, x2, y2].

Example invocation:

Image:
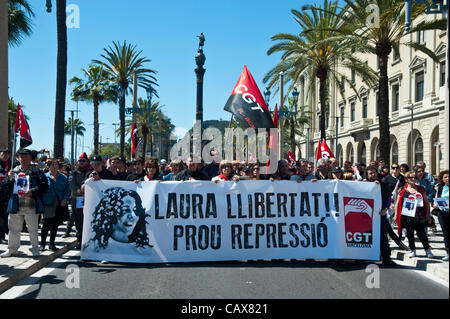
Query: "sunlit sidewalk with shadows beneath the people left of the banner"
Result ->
[[0, 225, 76, 294]]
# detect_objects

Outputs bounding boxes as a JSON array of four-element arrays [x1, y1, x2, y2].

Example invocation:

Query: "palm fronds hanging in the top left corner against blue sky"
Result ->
[[8, 0, 35, 47]]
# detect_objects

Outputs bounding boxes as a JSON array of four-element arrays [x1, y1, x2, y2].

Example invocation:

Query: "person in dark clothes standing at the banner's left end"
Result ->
[[67, 153, 92, 247]]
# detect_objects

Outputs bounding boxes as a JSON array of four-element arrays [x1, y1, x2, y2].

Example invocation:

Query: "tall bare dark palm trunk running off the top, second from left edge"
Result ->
[[53, 0, 67, 158]]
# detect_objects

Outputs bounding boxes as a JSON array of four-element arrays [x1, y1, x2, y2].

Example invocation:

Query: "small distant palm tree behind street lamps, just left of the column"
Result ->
[[125, 98, 162, 158]]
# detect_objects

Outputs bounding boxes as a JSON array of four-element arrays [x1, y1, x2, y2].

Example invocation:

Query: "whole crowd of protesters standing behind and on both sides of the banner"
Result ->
[[0, 149, 449, 264]]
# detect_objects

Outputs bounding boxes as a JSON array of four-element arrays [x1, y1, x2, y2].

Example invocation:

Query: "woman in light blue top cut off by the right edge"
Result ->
[[433, 170, 449, 261]]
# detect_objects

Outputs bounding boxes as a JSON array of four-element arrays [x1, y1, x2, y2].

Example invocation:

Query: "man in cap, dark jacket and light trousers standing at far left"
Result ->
[[0, 149, 48, 257]]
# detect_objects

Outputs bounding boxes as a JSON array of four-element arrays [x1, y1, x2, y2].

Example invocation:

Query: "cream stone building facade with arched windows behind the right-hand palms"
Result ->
[[297, 15, 449, 175]]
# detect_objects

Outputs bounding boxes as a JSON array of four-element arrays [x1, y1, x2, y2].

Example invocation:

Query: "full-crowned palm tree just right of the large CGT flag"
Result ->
[[263, 0, 377, 138]]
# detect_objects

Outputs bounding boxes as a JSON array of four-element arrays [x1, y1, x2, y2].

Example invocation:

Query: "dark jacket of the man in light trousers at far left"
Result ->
[[7, 166, 48, 214]]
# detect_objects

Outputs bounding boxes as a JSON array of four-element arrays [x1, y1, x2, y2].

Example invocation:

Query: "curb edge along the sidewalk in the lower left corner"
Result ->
[[0, 239, 77, 294]]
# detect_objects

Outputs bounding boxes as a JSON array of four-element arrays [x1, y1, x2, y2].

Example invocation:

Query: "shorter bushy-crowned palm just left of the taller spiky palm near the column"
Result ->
[[69, 65, 117, 154]]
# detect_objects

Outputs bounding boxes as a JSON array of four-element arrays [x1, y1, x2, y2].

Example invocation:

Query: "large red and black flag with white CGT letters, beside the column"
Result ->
[[224, 66, 274, 129]]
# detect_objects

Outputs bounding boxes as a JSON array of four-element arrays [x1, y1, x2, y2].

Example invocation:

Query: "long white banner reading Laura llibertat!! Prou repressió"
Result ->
[[81, 180, 381, 263]]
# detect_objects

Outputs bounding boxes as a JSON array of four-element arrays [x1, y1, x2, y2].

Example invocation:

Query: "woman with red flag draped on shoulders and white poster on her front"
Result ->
[[394, 171, 433, 258]]
